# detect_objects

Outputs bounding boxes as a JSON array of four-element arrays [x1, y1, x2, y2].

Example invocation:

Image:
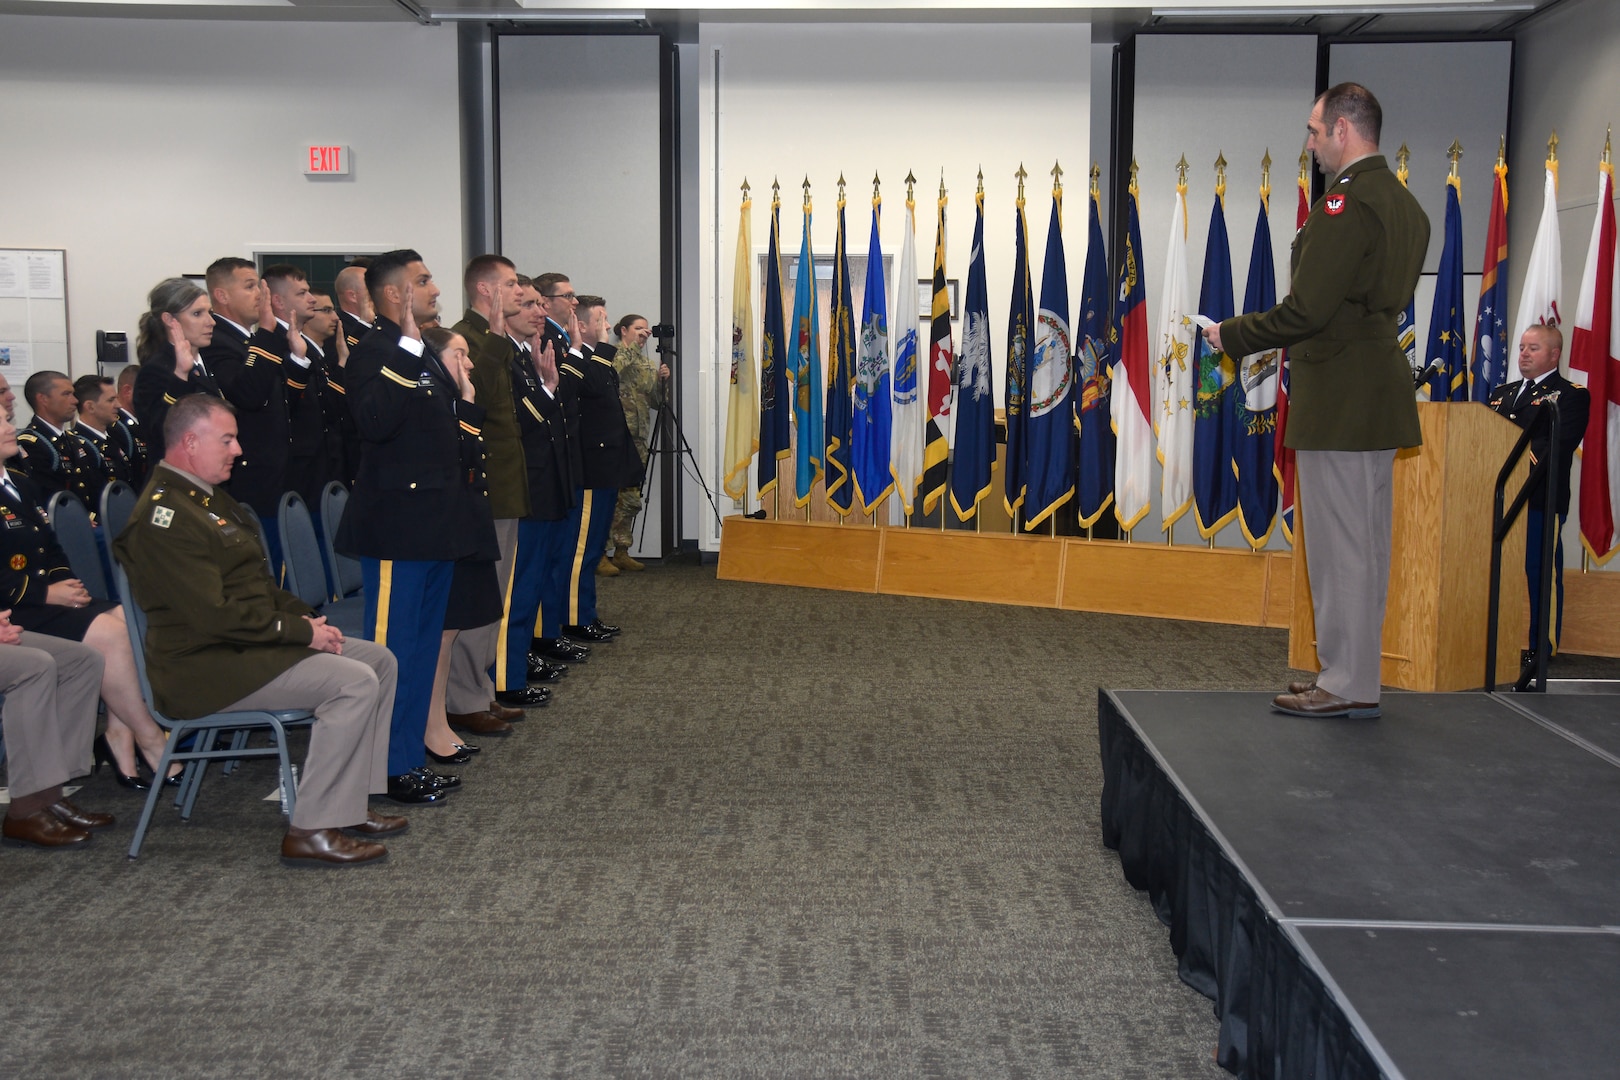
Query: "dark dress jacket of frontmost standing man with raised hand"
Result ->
[[328, 319, 484, 560]]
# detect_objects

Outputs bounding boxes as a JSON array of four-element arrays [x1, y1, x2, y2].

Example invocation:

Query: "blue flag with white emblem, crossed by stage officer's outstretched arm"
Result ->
[[1233, 188, 1281, 549]]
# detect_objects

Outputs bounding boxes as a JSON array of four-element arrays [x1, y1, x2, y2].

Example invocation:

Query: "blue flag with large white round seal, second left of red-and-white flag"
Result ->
[[1024, 179, 1074, 529]]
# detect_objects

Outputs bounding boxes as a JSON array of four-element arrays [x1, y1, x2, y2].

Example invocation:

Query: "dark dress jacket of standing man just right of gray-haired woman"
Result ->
[[203, 316, 292, 518]]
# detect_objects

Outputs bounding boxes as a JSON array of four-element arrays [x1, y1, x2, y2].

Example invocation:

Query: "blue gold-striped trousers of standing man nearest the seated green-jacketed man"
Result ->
[[360, 559, 455, 776]]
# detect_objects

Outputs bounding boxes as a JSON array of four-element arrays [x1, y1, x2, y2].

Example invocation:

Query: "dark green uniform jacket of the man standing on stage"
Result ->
[[1220, 154, 1429, 450]]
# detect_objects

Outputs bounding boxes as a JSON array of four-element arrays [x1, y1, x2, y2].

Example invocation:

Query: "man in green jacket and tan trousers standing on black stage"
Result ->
[[1204, 83, 1429, 717]]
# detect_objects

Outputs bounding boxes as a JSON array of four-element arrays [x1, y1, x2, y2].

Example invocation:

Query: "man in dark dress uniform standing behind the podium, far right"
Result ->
[[1490, 325, 1592, 662]]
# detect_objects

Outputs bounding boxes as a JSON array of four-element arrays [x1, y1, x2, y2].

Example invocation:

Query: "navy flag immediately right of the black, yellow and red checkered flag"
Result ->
[[951, 188, 996, 521]]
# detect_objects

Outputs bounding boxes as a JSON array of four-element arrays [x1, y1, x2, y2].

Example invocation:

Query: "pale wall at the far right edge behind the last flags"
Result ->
[[1508, 0, 1620, 570]]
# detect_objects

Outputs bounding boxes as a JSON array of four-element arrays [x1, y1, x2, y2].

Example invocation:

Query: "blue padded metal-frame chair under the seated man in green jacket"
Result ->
[[113, 567, 314, 858]]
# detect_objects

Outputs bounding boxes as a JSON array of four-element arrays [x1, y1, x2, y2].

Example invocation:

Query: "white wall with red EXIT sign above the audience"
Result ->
[[0, 15, 462, 382]]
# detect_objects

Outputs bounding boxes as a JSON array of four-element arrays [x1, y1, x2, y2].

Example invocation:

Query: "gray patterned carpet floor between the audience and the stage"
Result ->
[[9, 567, 1607, 1078]]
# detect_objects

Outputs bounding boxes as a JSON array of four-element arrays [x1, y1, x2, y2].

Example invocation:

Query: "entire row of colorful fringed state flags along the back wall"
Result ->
[[724, 146, 1620, 560]]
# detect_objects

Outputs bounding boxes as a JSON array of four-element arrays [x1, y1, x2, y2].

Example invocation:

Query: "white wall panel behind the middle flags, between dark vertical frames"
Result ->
[[689, 23, 1092, 547]]
